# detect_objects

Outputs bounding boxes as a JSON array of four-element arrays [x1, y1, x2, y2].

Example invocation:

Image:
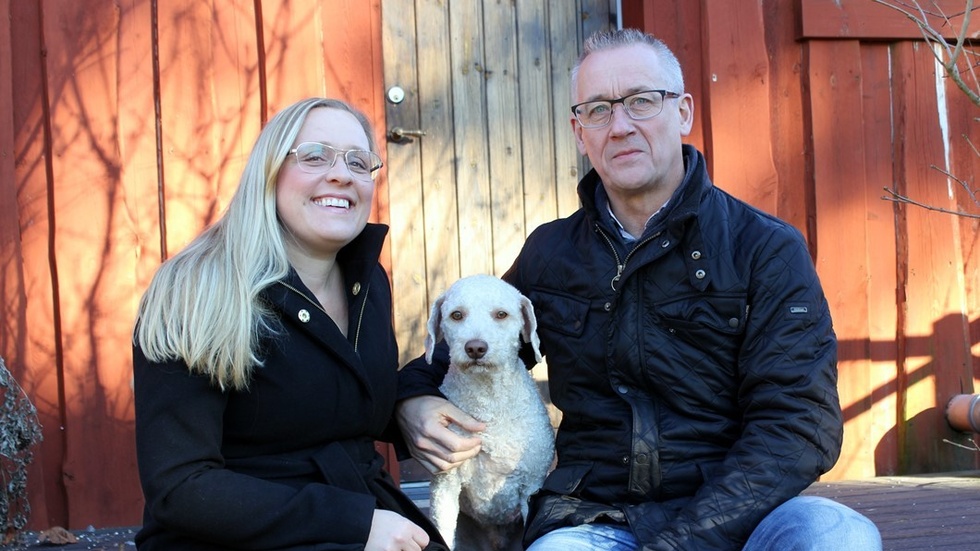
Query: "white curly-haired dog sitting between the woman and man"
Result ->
[[425, 275, 555, 551]]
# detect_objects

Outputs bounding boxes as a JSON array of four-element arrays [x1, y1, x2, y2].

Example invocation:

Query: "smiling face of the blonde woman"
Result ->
[[276, 107, 374, 258]]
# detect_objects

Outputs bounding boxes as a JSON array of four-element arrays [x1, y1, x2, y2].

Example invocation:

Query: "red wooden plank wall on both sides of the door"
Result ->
[[0, 0, 980, 528]]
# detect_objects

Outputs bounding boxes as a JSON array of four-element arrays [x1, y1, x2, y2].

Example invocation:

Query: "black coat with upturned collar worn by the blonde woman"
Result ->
[[134, 224, 438, 551]]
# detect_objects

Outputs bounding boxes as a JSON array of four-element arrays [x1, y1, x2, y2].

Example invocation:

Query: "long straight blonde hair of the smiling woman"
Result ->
[[133, 98, 377, 390]]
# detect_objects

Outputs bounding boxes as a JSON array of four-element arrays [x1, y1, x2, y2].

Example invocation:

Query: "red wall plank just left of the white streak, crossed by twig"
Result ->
[[892, 42, 975, 472]]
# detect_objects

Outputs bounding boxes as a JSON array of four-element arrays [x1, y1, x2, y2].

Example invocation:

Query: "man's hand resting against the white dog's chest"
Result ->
[[397, 396, 486, 474]]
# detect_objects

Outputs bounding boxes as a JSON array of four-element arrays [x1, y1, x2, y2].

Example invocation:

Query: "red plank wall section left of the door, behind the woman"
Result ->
[[0, 0, 387, 528]]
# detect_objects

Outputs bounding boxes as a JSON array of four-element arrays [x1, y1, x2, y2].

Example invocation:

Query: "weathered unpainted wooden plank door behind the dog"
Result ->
[[381, 0, 610, 480]]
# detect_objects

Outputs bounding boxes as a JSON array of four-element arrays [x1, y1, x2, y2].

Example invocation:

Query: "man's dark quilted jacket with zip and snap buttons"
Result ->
[[399, 146, 843, 550]]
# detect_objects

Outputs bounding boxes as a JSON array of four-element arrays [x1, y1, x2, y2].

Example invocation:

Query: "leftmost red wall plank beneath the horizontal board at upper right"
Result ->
[[805, 41, 875, 479]]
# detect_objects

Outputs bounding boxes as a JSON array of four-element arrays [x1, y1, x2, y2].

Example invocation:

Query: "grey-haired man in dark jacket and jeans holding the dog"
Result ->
[[398, 30, 881, 551]]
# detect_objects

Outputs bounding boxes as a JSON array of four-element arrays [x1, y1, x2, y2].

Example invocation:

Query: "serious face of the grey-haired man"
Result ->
[[572, 44, 694, 201]]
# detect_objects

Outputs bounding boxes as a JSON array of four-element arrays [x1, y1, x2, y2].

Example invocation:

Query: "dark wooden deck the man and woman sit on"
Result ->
[[0, 471, 980, 551]]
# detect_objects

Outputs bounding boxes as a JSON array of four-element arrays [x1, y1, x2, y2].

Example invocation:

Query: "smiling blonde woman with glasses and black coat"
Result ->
[[133, 98, 442, 551]]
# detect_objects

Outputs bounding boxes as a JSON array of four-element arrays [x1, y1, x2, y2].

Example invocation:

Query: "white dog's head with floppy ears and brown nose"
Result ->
[[425, 275, 541, 369]]
